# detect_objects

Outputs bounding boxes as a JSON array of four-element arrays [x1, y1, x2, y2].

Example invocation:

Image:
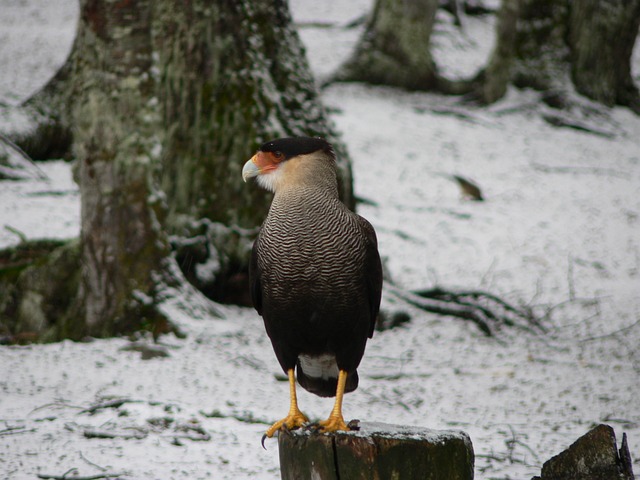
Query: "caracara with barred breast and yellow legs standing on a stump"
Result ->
[[242, 137, 382, 440]]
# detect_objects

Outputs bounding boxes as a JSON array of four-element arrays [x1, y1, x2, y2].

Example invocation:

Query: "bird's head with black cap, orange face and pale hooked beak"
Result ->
[[242, 137, 337, 192]]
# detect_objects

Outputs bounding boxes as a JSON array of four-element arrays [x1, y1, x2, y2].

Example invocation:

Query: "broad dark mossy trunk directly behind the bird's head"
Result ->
[[154, 0, 354, 230]]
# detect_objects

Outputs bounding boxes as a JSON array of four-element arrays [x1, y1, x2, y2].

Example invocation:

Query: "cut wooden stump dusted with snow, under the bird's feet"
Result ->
[[278, 422, 474, 480]]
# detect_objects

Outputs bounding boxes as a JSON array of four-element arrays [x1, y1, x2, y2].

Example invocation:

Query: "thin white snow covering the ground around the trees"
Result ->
[[0, 0, 640, 480]]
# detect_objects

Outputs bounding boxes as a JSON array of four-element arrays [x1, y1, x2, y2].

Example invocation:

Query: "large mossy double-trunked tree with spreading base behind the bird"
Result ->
[[0, 0, 354, 339]]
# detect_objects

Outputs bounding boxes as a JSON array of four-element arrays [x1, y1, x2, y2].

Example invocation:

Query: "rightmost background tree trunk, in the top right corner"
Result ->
[[569, 0, 640, 114]]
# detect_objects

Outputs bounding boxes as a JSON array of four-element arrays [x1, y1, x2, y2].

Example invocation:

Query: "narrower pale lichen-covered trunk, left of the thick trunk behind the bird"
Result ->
[[71, 0, 168, 336]]
